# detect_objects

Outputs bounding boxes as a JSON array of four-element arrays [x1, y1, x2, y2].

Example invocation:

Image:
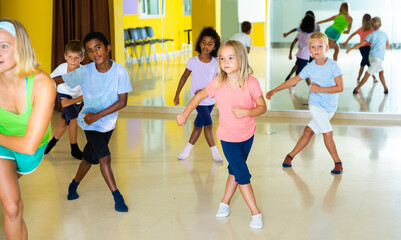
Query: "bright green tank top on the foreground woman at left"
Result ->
[[0, 75, 50, 147]]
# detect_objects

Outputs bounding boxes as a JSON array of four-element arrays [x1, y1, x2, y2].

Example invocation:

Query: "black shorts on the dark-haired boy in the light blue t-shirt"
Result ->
[[82, 130, 113, 164]]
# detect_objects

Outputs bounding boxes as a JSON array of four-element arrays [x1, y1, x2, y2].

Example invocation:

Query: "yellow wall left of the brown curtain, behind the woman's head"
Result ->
[[0, 0, 53, 73]]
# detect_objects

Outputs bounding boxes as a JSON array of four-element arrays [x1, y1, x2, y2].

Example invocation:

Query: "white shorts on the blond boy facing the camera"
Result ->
[[308, 105, 335, 135]]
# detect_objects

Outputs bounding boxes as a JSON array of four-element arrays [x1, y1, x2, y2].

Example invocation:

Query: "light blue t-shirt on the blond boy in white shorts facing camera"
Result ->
[[299, 58, 343, 113]]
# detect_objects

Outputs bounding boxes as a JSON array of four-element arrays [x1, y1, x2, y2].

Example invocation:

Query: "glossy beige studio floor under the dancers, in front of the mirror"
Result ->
[[0, 113, 401, 240]]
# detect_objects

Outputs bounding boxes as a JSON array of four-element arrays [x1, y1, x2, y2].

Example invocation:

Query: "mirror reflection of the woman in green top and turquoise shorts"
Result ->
[[317, 2, 352, 61]]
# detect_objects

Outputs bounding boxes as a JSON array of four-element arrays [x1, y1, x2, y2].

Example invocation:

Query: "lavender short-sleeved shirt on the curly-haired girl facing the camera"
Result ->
[[187, 56, 219, 106]]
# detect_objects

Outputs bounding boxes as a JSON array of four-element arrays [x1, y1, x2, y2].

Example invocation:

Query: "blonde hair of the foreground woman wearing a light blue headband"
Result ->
[[0, 18, 39, 77]]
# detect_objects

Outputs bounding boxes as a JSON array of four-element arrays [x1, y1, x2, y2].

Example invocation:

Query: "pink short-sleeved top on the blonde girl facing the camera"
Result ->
[[206, 76, 263, 142]]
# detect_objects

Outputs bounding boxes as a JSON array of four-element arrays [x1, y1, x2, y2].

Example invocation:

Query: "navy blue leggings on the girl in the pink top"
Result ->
[[221, 136, 253, 185]]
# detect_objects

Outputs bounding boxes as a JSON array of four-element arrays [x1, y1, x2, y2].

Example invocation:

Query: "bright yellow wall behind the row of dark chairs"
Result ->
[[124, 0, 191, 52]]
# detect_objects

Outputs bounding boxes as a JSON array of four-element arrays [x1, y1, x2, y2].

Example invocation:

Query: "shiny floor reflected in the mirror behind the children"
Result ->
[[128, 48, 401, 114]]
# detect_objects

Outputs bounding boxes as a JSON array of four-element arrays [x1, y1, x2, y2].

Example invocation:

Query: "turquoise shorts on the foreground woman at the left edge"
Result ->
[[0, 143, 47, 174]]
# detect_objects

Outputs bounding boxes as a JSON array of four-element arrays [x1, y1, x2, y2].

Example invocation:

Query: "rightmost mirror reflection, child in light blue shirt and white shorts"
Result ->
[[347, 17, 390, 94]]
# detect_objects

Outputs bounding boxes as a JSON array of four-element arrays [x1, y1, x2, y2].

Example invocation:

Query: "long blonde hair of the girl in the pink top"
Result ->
[[215, 40, 253, 88]]
